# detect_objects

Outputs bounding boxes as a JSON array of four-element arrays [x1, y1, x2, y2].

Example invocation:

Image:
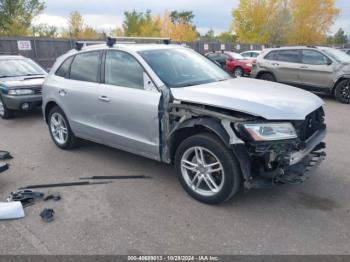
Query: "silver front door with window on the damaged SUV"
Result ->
[[97, 50, 161, 159]]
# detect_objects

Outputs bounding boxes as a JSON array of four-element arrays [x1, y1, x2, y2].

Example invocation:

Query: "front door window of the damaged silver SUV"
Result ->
[[105, 51, 144, 89]]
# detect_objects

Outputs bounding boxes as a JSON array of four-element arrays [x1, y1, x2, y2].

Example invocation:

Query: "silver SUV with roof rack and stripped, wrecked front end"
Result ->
[[43, 43, 326, 204]]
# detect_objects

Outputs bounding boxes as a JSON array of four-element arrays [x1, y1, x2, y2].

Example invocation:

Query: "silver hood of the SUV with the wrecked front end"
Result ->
[[171, 78, 324, 120]]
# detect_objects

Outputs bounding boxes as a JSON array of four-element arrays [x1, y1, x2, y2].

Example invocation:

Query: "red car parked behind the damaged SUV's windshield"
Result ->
[[206, 51, 252, 77]]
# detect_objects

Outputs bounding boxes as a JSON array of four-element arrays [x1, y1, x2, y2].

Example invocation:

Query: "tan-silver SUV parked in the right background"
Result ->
[[252, 46, 350, 104]]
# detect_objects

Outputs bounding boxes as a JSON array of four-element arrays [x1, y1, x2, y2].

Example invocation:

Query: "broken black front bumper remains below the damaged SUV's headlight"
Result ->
[[232, 128, 327, 189]]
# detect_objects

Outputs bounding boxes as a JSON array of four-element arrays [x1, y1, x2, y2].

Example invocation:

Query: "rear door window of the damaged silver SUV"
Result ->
[[70, 51, 100, 83]]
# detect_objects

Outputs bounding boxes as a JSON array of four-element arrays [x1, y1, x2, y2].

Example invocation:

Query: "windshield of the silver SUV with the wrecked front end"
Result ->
[[139, 48, 231, 87]]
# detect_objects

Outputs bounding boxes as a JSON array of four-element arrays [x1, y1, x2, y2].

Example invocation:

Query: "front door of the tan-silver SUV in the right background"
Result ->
[[299, 50, 333, 89]]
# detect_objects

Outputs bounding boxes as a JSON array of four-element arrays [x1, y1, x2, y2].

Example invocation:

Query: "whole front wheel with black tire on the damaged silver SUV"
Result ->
[[174, 134, 242, 204]]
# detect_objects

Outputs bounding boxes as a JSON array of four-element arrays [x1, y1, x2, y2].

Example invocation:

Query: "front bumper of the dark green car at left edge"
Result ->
[[2, 95, 42, 110]]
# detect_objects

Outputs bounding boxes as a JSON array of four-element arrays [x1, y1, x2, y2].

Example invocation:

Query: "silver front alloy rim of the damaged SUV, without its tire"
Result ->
[[181, 146, 225, 196]]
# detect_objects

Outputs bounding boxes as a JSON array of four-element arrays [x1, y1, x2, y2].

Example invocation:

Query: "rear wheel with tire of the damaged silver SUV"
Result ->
[[48, 106, 78, 150]]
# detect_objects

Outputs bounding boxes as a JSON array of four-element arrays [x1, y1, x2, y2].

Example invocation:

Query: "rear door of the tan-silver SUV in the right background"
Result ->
[[271, 49, 301, 84]]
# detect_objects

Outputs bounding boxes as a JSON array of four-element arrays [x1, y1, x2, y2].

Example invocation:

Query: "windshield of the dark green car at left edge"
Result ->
[[0, 59, 45, 78]]
